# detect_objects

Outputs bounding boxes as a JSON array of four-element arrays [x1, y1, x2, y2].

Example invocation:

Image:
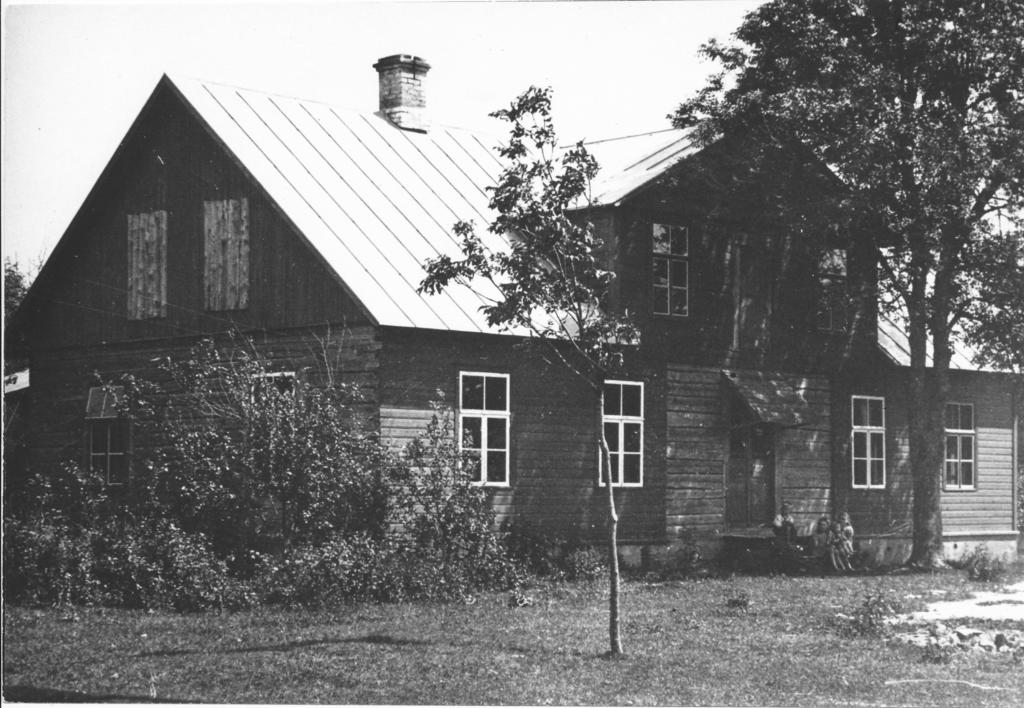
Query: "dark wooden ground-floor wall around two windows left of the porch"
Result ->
[[380, 328, 665, 543]]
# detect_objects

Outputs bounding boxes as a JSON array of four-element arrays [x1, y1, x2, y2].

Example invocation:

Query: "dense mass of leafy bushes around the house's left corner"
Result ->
[[4, 342, 532, 611]]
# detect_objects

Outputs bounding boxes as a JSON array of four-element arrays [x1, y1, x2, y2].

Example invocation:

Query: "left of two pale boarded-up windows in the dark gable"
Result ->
[[128, 209, 167, 320]]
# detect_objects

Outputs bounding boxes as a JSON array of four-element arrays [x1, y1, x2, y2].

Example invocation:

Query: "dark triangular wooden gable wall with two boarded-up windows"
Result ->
[[27, 80, 367, 348]]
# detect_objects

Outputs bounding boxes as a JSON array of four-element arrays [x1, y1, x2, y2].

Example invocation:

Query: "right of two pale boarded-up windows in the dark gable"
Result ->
[[203, 199, 249, 310]]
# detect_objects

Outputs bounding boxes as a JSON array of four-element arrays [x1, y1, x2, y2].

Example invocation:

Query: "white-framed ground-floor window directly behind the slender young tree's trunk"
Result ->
[[597, 381, 643, 487]]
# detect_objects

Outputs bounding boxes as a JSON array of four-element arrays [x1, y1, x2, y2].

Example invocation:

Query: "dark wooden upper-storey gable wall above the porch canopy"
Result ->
[[591, 144, 877, 379]]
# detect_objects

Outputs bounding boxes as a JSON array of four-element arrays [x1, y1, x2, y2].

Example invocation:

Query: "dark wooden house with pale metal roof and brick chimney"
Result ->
[[12, 55, 1020, 559]]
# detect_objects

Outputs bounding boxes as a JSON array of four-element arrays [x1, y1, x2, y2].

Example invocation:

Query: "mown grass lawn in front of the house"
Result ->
[[3, 572, 1024, 707]]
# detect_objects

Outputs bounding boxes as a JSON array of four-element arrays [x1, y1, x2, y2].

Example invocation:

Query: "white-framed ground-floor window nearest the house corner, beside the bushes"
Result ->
[[459, 371, 510, 487]]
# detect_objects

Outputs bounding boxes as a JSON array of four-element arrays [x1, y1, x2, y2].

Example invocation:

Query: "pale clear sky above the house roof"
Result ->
[[2, 0, 760, 270]]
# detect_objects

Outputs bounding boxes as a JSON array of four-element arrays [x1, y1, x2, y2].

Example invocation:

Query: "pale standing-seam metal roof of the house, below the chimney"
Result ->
[[167, 77, 693, 334]]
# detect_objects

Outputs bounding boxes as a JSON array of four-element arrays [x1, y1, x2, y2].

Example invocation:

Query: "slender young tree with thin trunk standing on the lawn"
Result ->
[[420, 87, 637, 655]]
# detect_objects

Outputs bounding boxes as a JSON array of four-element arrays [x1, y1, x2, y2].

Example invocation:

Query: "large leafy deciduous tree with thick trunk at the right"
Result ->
[[673, 0, 1024, 565]]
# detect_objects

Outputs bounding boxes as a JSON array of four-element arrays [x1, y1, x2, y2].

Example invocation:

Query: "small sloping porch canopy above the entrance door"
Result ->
[[722, 370, 816, 427]]
